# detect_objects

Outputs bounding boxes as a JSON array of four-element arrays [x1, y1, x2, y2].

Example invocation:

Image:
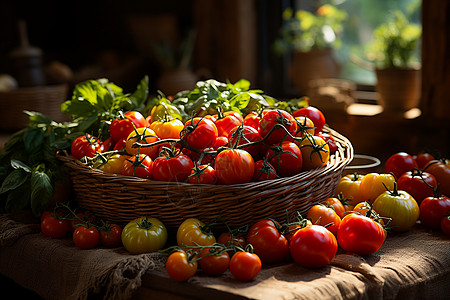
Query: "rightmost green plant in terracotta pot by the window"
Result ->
[[368, 10, 422, 112]]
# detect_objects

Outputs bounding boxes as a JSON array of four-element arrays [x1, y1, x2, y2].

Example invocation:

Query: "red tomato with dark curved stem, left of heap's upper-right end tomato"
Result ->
[[259, 109, 297, 145]]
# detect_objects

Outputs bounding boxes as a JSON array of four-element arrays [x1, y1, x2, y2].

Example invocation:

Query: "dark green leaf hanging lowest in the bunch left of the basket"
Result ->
[[31, 171, 55, 215]]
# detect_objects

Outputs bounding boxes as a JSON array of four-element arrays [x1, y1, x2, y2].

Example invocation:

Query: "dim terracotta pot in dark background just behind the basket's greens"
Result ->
[[157, 69, 198, 96]]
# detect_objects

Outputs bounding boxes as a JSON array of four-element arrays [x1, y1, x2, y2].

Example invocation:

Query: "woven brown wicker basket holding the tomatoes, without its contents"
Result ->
[[59, 127, 353, 229]]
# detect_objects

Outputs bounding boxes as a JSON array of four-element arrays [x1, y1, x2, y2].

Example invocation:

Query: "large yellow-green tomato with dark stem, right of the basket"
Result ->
[[372, 184, 420, 232]]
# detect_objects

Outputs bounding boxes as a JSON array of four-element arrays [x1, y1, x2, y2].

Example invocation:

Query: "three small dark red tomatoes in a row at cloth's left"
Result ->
[[41, 205, 122, 249]]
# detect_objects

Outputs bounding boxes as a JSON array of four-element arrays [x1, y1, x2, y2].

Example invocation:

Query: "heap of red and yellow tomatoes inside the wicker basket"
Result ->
[[71, 106, 337, 184]]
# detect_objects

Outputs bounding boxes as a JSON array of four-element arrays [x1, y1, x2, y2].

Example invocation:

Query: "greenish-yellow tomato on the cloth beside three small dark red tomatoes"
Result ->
[[122, 217, 167, 254]]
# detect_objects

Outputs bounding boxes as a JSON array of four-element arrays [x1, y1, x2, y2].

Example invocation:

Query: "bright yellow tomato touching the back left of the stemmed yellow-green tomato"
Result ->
[[359, 173, 395, 204]]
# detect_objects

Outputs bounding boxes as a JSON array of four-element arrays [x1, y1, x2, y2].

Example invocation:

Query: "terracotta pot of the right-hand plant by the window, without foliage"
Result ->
[[375, 68, 421, 112]]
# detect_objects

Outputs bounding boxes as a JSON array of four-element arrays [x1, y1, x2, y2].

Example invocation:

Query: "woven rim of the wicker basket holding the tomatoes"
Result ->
[[57, 125, 354, 191]]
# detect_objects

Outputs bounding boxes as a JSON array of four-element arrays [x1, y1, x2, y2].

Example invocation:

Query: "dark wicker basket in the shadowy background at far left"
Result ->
[[0, 84, 70, 131]]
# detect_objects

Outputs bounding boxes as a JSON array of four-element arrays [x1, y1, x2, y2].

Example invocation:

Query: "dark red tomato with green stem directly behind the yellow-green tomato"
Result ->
[[397, 169, 437, 205]]
